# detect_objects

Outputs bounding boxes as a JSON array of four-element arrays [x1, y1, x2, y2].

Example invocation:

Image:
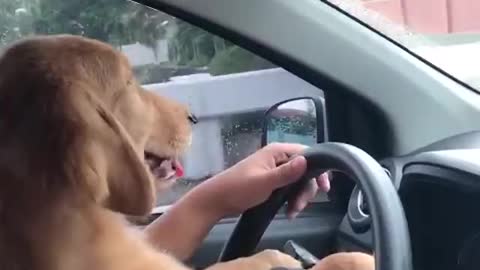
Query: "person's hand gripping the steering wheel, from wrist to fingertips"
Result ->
[[191, 143, 330, 218]]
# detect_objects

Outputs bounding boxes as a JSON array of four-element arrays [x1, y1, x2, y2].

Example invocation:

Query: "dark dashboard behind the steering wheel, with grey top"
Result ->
[[337, 132, 480, 270]]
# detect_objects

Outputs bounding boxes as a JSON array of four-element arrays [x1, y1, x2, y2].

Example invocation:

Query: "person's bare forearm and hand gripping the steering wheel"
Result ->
[[142, 144, 329, 260]]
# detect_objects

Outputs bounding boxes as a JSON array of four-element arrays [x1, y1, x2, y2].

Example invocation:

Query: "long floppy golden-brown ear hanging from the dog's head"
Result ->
[[76, 91, 156, 216]]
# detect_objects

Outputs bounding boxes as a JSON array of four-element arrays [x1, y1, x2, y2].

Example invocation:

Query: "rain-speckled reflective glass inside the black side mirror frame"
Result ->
[[265, 98, 318, 145]]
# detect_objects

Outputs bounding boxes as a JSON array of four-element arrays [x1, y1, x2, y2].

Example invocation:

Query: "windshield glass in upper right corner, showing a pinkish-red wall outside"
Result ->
[[326, 0, 480, 91]]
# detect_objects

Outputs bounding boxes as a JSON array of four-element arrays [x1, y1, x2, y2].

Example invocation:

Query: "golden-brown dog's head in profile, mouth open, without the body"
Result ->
[[0, 35, 196, 215]]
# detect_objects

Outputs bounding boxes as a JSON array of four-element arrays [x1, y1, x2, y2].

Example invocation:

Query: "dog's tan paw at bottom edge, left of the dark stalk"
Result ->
[[248, 249, 302, 269]]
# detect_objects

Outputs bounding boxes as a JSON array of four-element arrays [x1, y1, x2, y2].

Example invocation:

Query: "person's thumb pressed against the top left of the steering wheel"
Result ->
[[266, 156, 307, 189]]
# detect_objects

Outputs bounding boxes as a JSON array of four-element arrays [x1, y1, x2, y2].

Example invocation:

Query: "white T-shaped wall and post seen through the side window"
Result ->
[[145, 69, 323, 177]]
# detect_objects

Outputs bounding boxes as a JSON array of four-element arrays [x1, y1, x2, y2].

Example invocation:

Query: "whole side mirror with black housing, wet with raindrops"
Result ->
[[262, 97, 326, 146]]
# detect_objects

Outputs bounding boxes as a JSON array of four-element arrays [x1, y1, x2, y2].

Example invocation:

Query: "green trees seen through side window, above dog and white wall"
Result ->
[[0, 0, 273, 75]]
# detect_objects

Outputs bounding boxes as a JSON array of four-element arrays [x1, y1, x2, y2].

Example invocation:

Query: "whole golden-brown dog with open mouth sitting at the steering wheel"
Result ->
[[0, 35, 374, 270]]
